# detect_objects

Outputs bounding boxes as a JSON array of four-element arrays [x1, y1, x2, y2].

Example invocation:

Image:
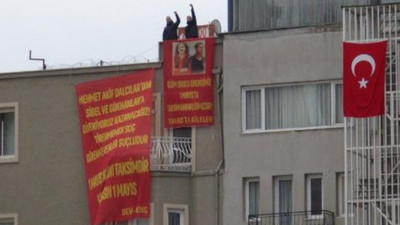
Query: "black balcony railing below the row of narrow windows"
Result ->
[[248, 210, 335, 225]]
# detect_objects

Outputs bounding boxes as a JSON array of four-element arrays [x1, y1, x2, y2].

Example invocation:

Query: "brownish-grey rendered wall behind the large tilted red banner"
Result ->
[[0, 35, 222, 225]]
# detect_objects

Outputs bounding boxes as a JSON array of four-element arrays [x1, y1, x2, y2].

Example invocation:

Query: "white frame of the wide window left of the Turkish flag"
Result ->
[[241, 80, 344, 134]]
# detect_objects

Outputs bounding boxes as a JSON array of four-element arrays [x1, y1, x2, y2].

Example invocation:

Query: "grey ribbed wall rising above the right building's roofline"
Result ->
[[228, 0, 376, 31]]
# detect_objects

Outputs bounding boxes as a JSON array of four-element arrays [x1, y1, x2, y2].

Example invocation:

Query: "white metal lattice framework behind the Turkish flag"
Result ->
[[342, 3, 400, 225]]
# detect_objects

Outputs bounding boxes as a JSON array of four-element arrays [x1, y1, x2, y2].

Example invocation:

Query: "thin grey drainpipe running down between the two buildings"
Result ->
[[212, 67, 225, 225]]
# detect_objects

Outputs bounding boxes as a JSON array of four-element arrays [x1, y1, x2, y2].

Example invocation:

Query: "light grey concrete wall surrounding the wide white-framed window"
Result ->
[[223, 26, 344, 225]]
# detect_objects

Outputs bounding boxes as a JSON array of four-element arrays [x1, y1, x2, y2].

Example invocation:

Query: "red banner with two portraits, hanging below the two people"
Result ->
[[163, 38, 215, 128]]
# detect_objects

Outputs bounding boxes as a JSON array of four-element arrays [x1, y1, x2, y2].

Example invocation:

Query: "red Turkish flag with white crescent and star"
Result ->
[[343, 41, 387, 118]]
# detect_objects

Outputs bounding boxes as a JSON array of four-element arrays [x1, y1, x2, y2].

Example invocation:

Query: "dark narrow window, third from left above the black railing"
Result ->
[[307, 175, 323, 217]]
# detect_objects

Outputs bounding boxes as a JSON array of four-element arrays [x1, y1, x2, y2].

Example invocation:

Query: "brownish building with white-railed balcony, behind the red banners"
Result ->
[[0, 38, 222, 225]]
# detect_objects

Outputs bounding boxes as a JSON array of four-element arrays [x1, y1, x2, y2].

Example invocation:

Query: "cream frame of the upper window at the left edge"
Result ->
[[0, 102, 18, 164]]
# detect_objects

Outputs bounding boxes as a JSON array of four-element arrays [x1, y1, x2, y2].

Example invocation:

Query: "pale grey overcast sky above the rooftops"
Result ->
[[0, 0, 227, 73]]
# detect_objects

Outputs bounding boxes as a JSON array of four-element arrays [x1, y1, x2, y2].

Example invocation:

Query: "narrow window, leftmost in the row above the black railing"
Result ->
[[244, 178, 260, 220]]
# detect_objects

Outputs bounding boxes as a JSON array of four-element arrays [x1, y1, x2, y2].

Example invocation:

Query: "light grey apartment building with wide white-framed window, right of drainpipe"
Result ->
[[223, 0, 399, 225]]
